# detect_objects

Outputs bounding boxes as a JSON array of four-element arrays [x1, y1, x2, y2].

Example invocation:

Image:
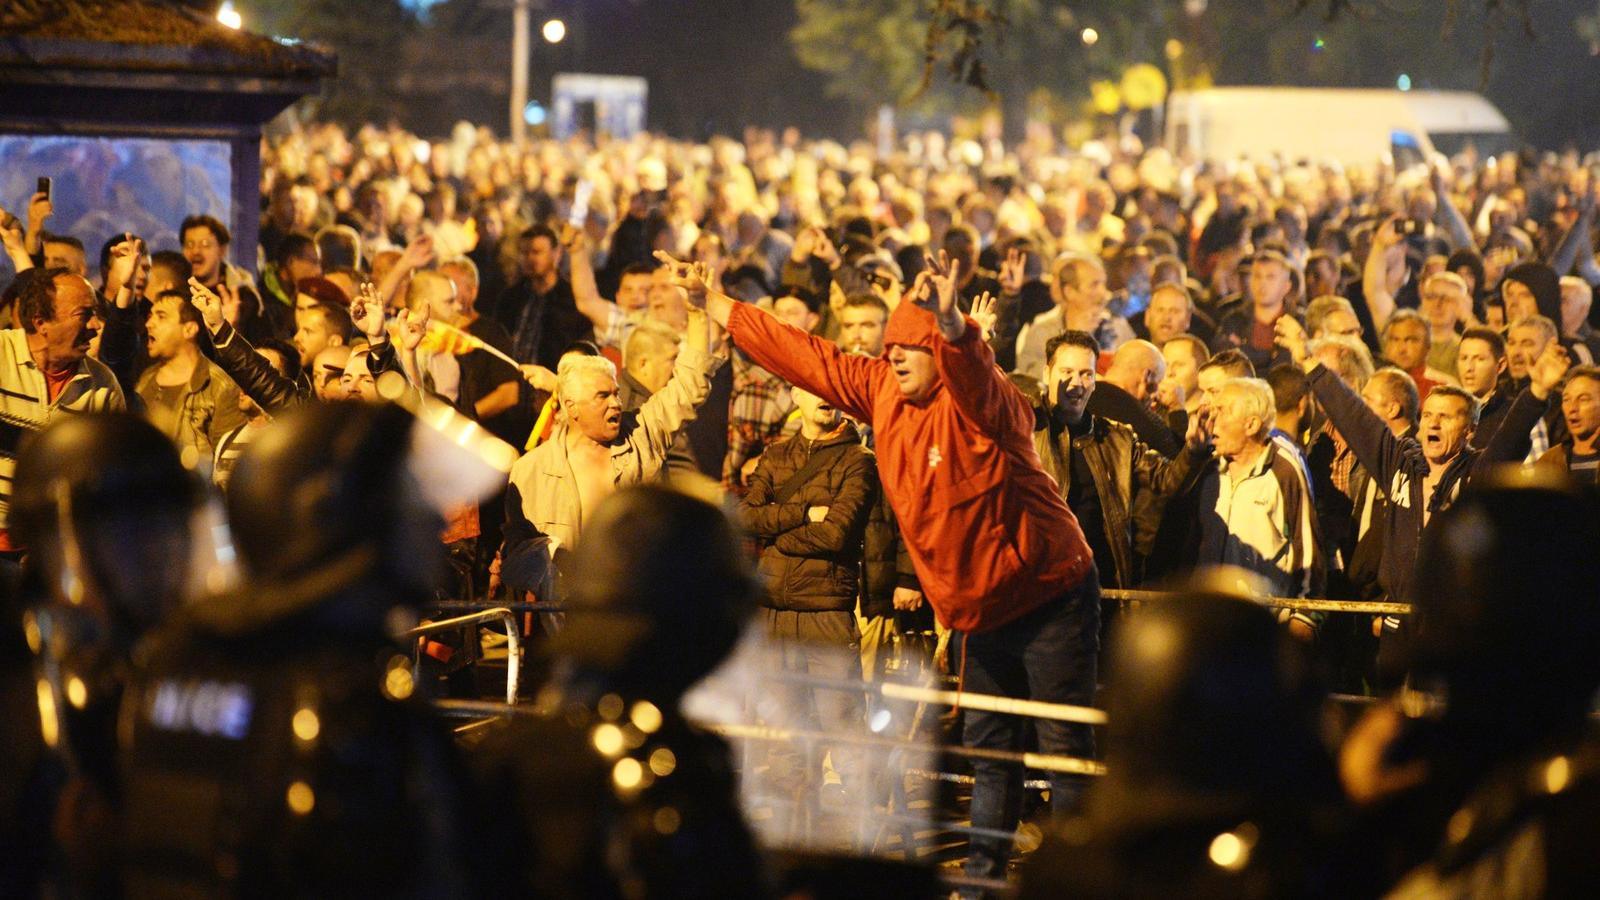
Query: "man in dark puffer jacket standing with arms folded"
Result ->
[[739, 381, 878, 800]]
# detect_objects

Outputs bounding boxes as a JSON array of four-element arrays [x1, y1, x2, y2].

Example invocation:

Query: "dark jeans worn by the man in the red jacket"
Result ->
[[962, 572, 1101, 878]]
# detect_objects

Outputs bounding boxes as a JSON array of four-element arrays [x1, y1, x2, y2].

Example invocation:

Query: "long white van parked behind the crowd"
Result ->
[[1165, 88, 1517, 167]]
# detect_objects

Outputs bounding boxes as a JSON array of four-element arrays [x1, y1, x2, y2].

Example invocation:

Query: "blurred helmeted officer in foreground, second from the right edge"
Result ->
[[1021, 569, 1338, 898]]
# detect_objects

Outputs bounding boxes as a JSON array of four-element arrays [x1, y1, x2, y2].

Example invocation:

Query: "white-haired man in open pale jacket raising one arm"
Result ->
[[501, 309, 718, 599]]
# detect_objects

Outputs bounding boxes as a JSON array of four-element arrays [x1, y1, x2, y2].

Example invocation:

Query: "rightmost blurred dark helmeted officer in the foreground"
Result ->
[[1339, 469, 1600, 897]]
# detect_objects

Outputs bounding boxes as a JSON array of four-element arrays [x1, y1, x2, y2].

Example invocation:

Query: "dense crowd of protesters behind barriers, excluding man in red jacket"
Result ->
[[0, 123, 1600, 896]]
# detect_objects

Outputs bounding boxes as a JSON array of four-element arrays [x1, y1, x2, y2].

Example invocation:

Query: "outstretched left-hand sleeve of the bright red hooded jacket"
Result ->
[[728, 303, 888, 423]]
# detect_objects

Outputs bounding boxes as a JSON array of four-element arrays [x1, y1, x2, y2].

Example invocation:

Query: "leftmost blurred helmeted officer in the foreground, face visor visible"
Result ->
[[0, 413, 200, 897]]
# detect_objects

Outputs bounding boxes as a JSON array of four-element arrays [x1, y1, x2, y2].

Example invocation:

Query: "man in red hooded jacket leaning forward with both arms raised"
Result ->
[[662, 255, 1099, 878]]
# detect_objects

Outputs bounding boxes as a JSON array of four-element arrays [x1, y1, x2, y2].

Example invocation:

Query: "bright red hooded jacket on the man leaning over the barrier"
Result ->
[[728, 301, 1094, 633]]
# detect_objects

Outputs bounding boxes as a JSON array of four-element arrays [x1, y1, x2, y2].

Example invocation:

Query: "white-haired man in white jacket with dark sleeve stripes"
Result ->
[[1198, 378, 1323, 639]]
